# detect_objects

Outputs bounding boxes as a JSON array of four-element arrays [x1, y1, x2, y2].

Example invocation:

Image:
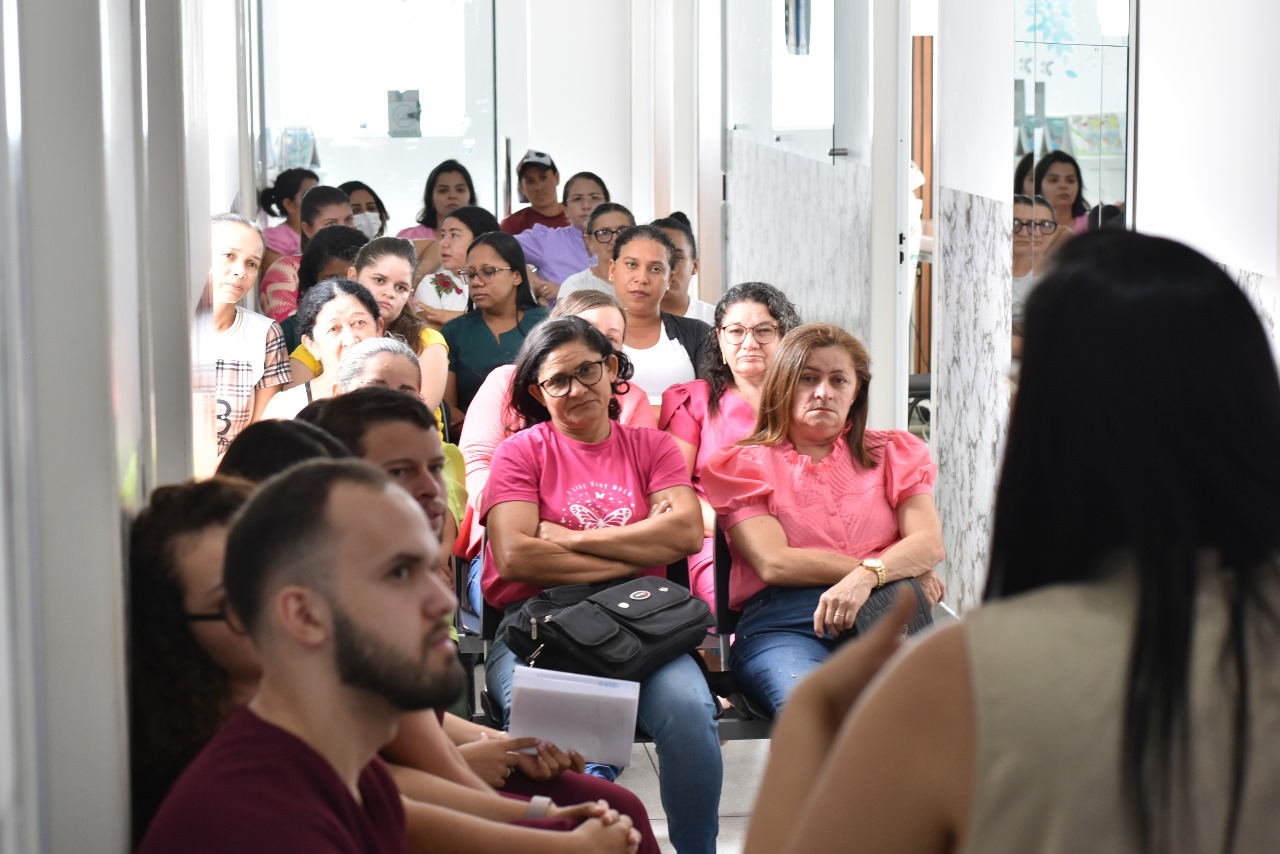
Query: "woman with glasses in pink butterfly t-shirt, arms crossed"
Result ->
[[480, 318, 723, 854]]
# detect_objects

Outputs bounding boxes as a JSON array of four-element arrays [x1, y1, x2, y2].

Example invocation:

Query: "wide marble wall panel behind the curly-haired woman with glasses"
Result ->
[[727, 138, 870, 341]]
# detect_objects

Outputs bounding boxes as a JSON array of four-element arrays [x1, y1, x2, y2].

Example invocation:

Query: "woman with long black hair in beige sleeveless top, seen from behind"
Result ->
[[746, 232, 1280, 854]]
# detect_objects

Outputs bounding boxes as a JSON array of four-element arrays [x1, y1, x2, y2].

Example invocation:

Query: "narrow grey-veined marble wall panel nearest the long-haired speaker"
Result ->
[[931, 187, 1014, 611]]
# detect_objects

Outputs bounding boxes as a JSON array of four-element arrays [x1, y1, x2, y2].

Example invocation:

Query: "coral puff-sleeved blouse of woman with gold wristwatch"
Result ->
[[703, 430, 938, 609]]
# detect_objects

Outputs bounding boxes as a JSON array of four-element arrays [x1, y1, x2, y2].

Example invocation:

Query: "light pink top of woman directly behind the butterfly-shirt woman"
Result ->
[[458, 365, 658, 554]]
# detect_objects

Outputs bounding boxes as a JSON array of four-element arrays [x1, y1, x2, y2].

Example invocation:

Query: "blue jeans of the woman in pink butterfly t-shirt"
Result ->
[[485, 621, 723, 854]]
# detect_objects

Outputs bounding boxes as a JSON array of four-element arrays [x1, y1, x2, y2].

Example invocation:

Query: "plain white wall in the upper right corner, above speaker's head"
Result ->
[[1134, 0, 1280, 278]]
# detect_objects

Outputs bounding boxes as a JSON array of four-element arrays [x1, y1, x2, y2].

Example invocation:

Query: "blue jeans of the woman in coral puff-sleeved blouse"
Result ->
[[730, 586, 855, 718]]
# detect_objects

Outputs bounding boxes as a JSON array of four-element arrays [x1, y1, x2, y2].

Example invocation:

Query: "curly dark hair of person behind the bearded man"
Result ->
[[128, 476, 253, 840]]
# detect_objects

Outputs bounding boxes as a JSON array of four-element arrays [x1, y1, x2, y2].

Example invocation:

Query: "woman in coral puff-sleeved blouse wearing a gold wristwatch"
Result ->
[[701, 324, 943, 714]]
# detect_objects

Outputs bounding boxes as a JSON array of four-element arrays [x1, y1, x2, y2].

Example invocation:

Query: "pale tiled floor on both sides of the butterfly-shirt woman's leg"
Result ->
[[618, 740, 769, 854]]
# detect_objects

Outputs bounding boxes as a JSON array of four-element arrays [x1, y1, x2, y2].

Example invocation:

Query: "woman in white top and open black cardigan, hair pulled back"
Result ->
[[609, 225, 713, 412]]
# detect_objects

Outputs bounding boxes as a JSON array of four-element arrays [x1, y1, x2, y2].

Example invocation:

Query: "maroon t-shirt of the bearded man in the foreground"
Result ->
[[138, 708, 408, 854]]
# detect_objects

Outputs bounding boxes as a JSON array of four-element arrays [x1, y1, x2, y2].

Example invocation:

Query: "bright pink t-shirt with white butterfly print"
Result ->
[[480, 421, 689, 608]]
